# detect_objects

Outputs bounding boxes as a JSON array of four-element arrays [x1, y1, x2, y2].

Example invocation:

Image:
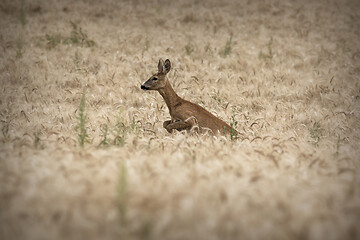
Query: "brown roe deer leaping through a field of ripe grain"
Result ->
[[141, 59, 238, 136]]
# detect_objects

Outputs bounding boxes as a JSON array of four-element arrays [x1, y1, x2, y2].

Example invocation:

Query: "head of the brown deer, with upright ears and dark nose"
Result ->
[[141, 58, 171, 90]]
